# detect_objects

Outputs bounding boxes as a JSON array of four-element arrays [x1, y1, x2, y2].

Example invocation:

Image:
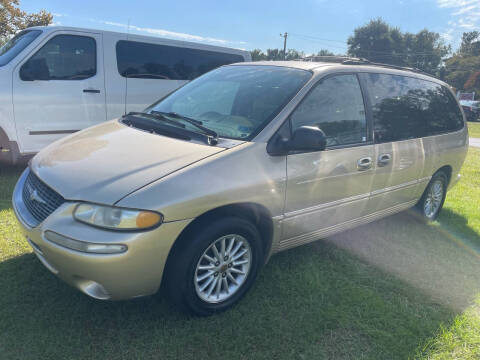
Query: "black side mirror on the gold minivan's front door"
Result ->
[[267, 126, 327, 156]]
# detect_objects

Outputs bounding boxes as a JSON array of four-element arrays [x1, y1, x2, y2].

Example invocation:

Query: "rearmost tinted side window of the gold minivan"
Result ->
[[425, 81, 463, 135]]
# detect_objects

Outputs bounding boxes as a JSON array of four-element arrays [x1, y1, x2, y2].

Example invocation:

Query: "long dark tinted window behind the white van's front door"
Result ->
[[117, 40, 244, 80]]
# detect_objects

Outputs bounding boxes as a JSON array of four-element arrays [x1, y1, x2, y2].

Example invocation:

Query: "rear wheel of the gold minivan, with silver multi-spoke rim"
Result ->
[[416, 171, 448, 222]]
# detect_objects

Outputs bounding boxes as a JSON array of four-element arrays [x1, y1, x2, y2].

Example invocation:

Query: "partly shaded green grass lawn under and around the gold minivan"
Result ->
[[0, 148, 480, 359]]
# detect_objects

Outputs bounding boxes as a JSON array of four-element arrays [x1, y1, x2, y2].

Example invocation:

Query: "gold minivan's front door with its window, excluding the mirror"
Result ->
[[280, 74, 375, 248]]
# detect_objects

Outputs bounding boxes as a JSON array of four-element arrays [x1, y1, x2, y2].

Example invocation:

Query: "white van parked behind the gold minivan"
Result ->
[[0, 27, 250, 163]]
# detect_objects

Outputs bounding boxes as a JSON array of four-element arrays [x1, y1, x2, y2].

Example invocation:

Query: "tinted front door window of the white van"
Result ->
[[20, 35, 97, 80]]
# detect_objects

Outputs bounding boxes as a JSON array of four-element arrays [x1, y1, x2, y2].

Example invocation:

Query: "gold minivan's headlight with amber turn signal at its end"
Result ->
[[73, 203, 163, 230]]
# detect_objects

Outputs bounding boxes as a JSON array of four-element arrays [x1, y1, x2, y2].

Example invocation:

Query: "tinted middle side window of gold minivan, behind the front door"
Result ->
[[361, 74, 431, 143]]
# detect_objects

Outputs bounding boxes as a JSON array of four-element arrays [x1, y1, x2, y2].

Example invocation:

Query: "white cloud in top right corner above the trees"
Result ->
[[437, 0, 480, 48]]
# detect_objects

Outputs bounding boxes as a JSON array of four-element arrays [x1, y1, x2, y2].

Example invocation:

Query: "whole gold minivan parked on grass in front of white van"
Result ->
[[13, 59, 468, 315]]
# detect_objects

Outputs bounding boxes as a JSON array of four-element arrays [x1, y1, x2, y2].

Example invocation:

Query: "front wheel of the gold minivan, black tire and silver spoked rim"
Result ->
[[165, 217, 263, 316]]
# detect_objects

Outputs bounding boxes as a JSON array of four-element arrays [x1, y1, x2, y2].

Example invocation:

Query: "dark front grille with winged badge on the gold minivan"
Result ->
[[22, 171, 65, 223]]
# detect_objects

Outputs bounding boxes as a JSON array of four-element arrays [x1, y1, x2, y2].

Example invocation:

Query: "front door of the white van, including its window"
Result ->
[[13, 31, 106, 153]]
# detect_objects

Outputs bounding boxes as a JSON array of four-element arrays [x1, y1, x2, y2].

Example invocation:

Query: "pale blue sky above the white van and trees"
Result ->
[[21, 0, 480, 54]]
